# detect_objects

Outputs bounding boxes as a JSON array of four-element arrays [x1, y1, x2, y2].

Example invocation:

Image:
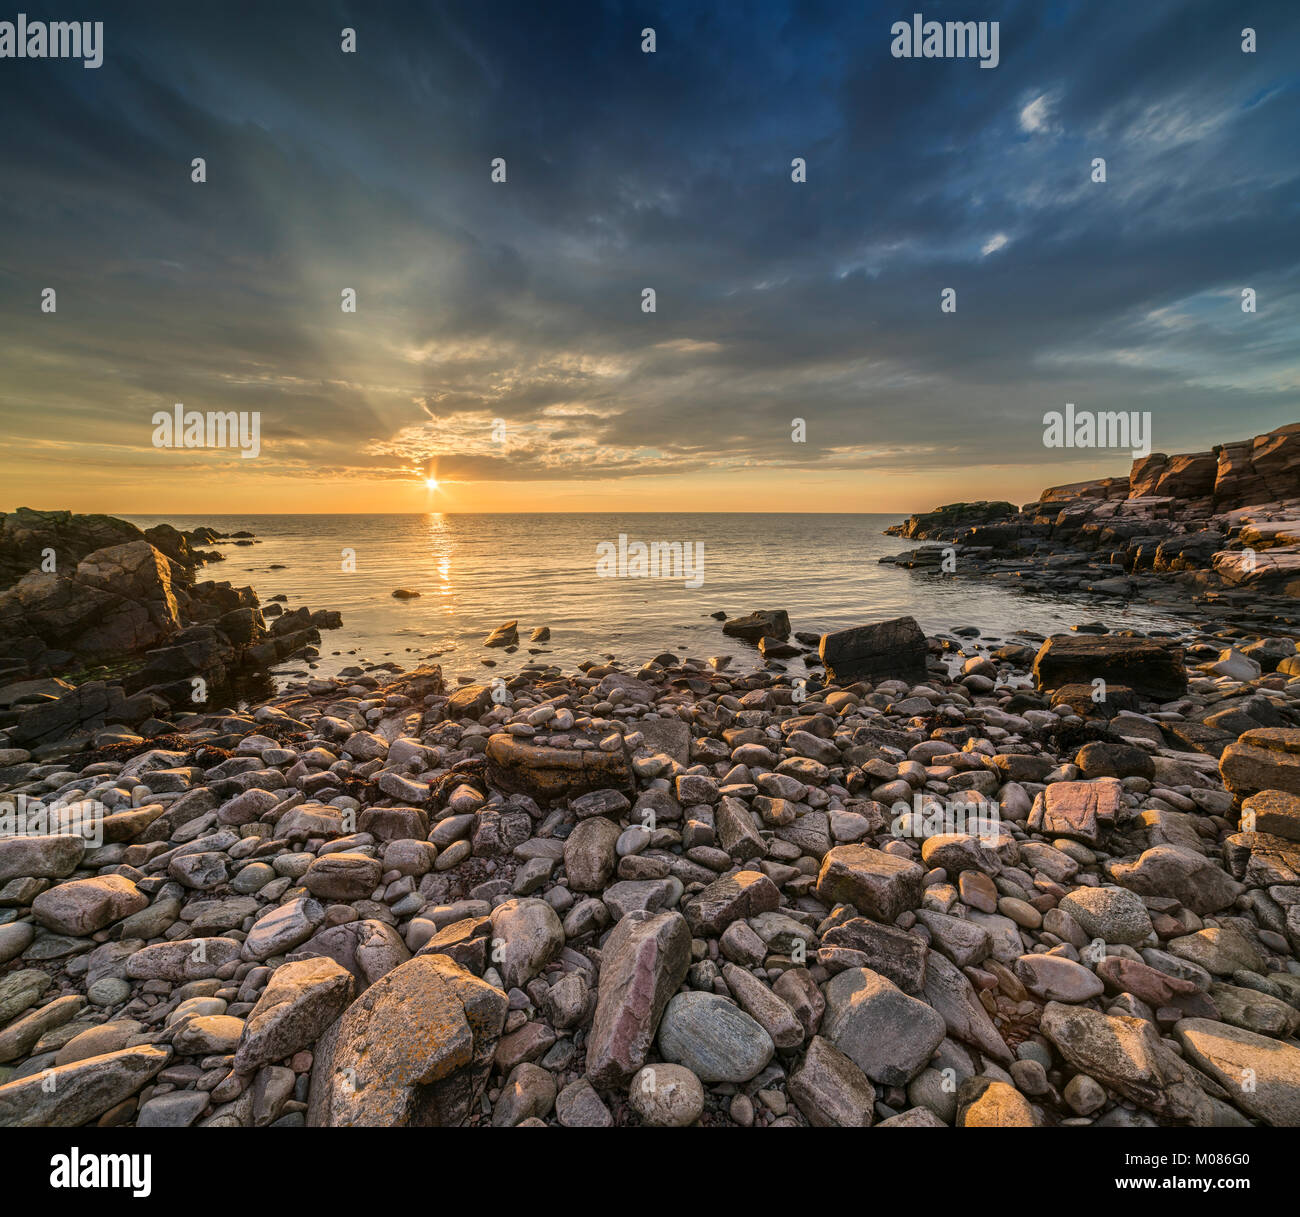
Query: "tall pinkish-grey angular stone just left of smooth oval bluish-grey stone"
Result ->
[[586, 911, 690, 1087]]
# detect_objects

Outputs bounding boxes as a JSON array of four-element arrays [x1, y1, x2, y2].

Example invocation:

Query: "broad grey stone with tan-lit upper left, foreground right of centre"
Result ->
[[822, 967, 946, 1086]]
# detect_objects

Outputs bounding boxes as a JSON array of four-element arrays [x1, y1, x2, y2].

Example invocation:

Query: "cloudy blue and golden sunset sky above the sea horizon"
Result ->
[[0, 0, 1300, 515]]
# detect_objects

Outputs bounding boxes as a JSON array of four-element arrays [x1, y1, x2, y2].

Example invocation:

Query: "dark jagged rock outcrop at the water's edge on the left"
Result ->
[[0, 507, 342, 758]]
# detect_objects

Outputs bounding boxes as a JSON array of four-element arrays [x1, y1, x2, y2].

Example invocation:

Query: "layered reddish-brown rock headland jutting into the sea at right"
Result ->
[[881, 423, 1300, 635]]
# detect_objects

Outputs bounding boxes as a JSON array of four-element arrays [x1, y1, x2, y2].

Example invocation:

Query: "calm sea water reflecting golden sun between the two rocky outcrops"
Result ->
[[131, 514, 1175, 676]]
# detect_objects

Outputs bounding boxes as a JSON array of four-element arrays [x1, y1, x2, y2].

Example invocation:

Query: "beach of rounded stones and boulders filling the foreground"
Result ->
[[0, 612, 1300, 1127]]
